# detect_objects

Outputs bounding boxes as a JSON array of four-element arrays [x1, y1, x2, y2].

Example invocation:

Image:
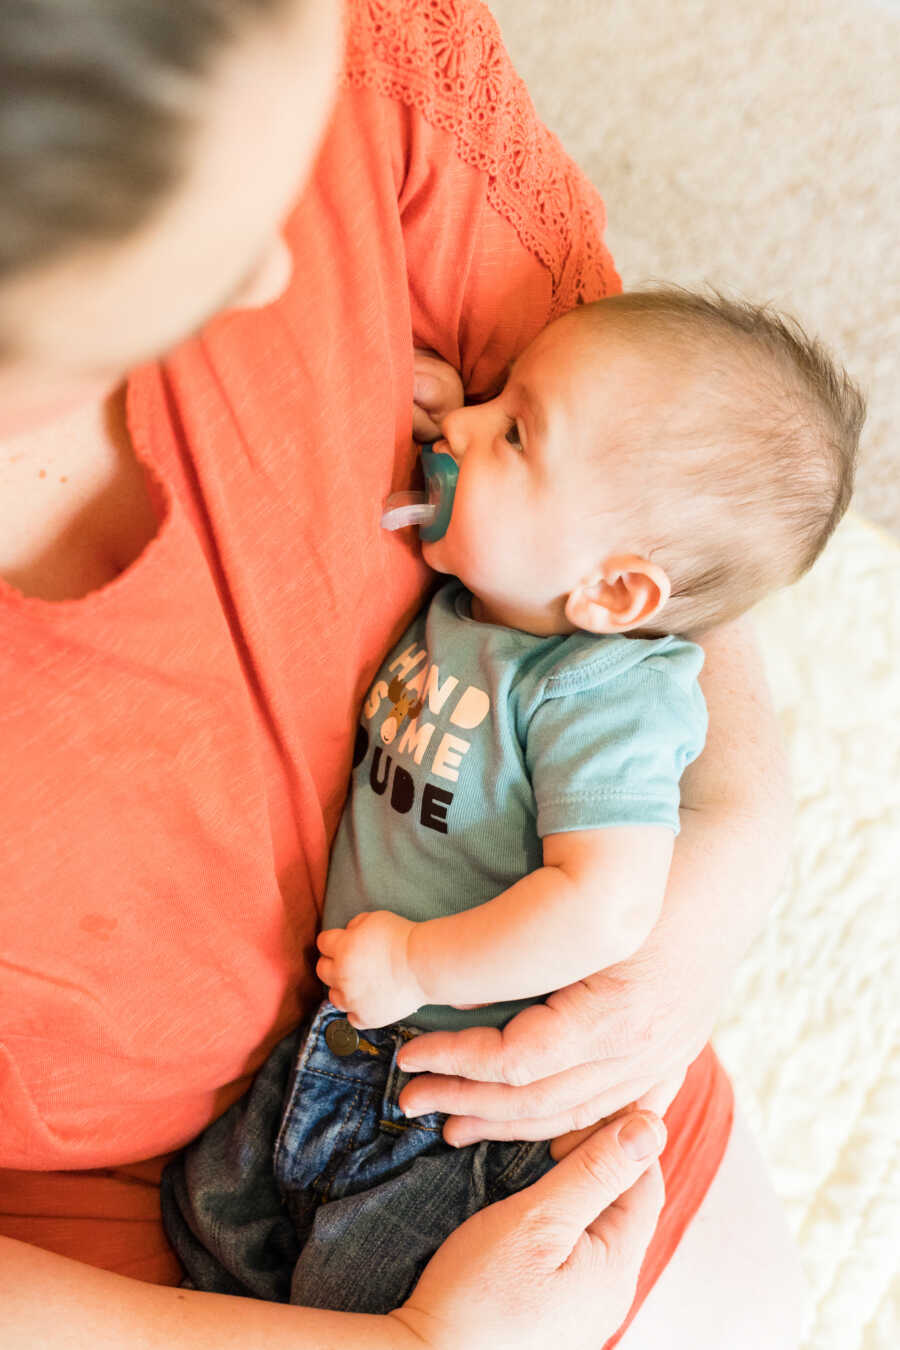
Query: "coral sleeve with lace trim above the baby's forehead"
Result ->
[[341, 0, 622, 398]]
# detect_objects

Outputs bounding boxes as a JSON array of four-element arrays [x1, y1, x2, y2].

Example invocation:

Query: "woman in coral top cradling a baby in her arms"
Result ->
[[0, 0, 796, 1350]]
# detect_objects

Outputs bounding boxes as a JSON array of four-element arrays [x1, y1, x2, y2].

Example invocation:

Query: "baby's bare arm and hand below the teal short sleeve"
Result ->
[[318, 825, 673, 1026]]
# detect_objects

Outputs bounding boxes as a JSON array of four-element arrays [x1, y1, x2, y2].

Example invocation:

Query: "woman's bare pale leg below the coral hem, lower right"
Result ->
[[620, 1110, 804, 1350]]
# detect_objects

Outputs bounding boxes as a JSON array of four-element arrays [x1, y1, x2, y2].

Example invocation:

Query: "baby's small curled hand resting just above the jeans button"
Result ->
[[316, 910, 429, 1030]]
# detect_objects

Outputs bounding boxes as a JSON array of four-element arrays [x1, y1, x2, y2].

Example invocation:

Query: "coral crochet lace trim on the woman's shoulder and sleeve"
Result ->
[[343, 0, 619, 317]]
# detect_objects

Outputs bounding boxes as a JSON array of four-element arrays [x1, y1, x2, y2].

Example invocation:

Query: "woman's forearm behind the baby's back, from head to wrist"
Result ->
[[657, 618, 792, 981]]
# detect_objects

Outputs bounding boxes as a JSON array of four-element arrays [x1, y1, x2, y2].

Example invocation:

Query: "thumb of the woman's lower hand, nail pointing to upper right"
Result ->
[[521, 1111, 665, 1261]]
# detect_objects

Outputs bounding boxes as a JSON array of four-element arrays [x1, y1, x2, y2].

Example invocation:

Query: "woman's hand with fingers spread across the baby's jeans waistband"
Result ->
[[398, 925, 723, 1145]]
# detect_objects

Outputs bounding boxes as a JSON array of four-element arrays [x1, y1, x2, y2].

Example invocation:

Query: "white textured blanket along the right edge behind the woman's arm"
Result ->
[[715, 516, 900, 1350]]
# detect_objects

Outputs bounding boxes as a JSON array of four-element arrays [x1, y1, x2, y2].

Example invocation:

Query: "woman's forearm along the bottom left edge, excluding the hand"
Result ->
[[0, 1238, 421, 1350]]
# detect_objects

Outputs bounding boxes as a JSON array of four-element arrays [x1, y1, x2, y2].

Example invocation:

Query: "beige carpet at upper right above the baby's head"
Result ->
[[488, 0, 900, 536]]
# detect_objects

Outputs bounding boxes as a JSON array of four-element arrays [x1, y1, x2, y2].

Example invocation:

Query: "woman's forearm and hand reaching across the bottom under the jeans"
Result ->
[[0, 1112, 665, 1350]]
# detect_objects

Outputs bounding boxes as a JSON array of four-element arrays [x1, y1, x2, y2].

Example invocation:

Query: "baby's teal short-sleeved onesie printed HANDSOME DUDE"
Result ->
[[322, 581, 707, 1031]]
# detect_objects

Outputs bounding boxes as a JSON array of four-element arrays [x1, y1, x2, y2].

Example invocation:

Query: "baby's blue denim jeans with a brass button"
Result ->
[[162, 1003, 553, 1312]]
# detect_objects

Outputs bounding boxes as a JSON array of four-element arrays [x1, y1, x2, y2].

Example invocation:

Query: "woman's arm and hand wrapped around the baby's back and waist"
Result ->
[[399, 620, 791, 1143]]
